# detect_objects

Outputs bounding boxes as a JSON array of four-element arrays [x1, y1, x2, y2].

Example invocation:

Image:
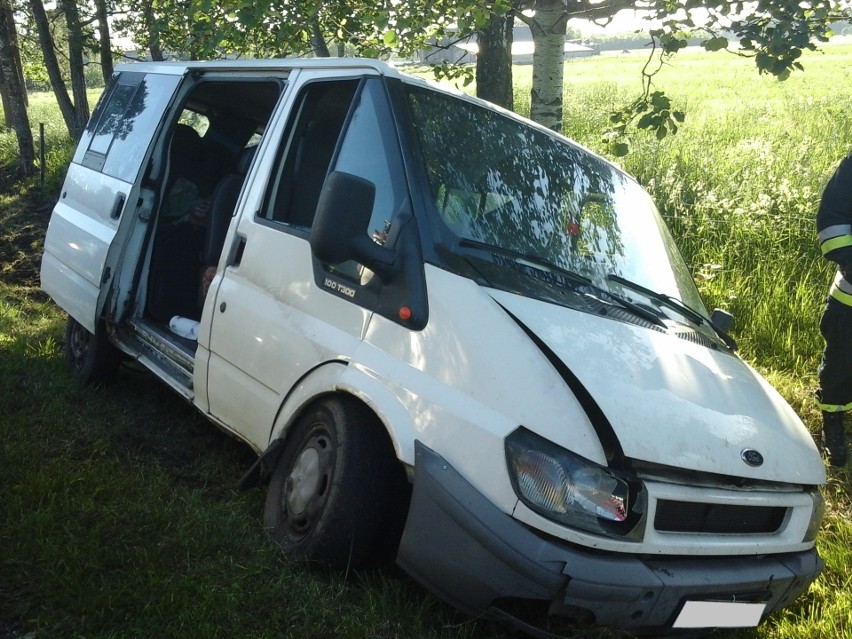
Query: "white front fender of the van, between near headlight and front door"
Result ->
[[358, 264, 606, 513]]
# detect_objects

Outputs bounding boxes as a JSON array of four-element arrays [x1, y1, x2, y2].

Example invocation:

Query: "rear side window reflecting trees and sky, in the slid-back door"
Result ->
[[74, 73, 181, 182]]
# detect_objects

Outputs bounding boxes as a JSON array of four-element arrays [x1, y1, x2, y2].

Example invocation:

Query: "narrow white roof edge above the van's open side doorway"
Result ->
[[116, 58, 400, 77]]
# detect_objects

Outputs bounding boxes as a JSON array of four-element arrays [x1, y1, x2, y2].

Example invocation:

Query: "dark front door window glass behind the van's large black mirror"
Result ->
[[261, 80, 359, 229]]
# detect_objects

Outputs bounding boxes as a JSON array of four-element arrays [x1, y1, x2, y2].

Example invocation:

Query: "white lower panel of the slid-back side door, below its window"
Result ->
[[41, 163, 132, 332]]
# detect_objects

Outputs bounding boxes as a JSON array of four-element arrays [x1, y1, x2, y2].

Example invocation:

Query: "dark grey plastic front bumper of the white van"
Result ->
[[397, 442, 822, 632]]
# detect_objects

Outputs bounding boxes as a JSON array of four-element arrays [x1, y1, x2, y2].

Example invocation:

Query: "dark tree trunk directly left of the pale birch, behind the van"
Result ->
[[476, 11, 514, 111]]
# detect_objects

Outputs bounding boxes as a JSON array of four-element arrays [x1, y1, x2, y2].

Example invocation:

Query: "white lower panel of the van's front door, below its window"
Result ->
[[207, 230, 369, 447]]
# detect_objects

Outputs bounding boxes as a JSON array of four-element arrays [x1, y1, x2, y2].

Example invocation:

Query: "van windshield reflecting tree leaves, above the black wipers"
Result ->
[[408, 86, 706, 315]]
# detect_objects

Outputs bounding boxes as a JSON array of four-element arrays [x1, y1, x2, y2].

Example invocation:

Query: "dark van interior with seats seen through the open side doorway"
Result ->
[[144, 80, 281, 336]]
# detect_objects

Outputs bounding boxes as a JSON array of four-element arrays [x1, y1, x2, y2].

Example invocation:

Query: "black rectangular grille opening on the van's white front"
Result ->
[[654, 499, 787, 535]]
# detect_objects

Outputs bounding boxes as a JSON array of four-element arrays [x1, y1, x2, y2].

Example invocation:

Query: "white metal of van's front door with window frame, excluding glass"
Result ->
[[194, 60, 386, 440]]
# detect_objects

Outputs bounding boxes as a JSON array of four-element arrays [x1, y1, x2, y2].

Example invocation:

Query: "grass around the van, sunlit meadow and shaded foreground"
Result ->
[[0, 45, 852, 639]]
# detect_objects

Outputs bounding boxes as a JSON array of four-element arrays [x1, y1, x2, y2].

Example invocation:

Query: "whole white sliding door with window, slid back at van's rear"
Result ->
[[41, 72, 182, 333]]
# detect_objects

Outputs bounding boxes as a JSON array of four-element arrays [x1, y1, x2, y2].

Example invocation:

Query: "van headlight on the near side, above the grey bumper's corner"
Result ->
[[506, 428, 644, 538]]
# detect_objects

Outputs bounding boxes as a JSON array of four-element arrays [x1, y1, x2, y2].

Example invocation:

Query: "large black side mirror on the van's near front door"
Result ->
[[310, 171, 396, 273]]
